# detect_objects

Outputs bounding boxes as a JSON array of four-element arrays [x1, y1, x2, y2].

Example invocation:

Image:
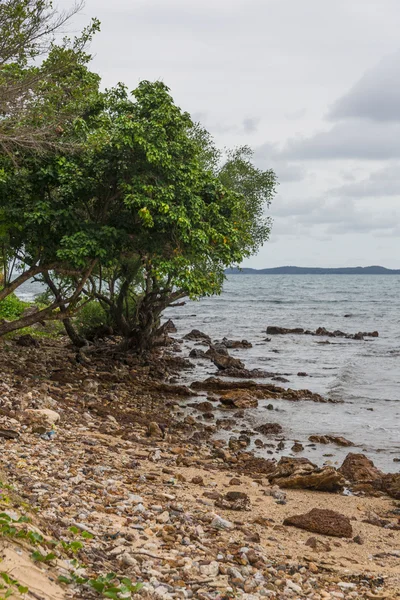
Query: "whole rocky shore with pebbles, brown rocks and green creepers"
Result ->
[[0, 338, 400, 600]]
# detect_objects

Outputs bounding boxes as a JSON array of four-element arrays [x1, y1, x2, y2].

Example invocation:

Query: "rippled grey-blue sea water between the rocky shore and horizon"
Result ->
[[165, 275, 400, 472]]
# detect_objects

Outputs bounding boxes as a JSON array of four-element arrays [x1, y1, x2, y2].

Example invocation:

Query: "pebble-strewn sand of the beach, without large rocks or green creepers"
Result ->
[[0, 340, 400, 600]]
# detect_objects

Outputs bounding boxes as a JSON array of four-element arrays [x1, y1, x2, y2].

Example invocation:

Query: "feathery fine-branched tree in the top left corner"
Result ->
[[0, 0, 99, 155]]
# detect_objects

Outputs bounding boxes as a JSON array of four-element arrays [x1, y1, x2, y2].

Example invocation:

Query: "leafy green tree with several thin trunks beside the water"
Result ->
[[39, 82, 275, 351]]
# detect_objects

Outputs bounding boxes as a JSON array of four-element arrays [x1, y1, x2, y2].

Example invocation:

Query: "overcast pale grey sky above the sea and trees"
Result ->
[[58, 0, 400, 268]]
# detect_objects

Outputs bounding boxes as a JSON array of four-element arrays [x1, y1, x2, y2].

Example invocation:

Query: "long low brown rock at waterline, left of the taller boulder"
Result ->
[[268, 456, 345, 492]]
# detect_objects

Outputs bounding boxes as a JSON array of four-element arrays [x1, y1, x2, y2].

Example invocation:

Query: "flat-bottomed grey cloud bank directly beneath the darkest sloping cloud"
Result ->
[[280, 120, 400, 160]]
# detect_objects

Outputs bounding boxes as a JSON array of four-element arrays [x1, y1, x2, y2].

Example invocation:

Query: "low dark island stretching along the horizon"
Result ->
[[225, 266, 400, 275]]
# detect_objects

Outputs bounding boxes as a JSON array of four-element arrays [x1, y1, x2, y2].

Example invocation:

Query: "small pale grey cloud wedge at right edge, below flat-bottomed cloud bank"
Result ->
[[329, 162, 400, 198]]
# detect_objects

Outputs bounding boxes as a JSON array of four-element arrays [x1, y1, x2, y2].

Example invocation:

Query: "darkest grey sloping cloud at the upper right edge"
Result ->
[[328, 51, 400, 122]]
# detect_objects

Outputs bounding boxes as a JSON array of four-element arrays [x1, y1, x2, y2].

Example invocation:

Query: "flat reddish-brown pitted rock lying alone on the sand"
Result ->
[[283, 508, 353, 538]]
